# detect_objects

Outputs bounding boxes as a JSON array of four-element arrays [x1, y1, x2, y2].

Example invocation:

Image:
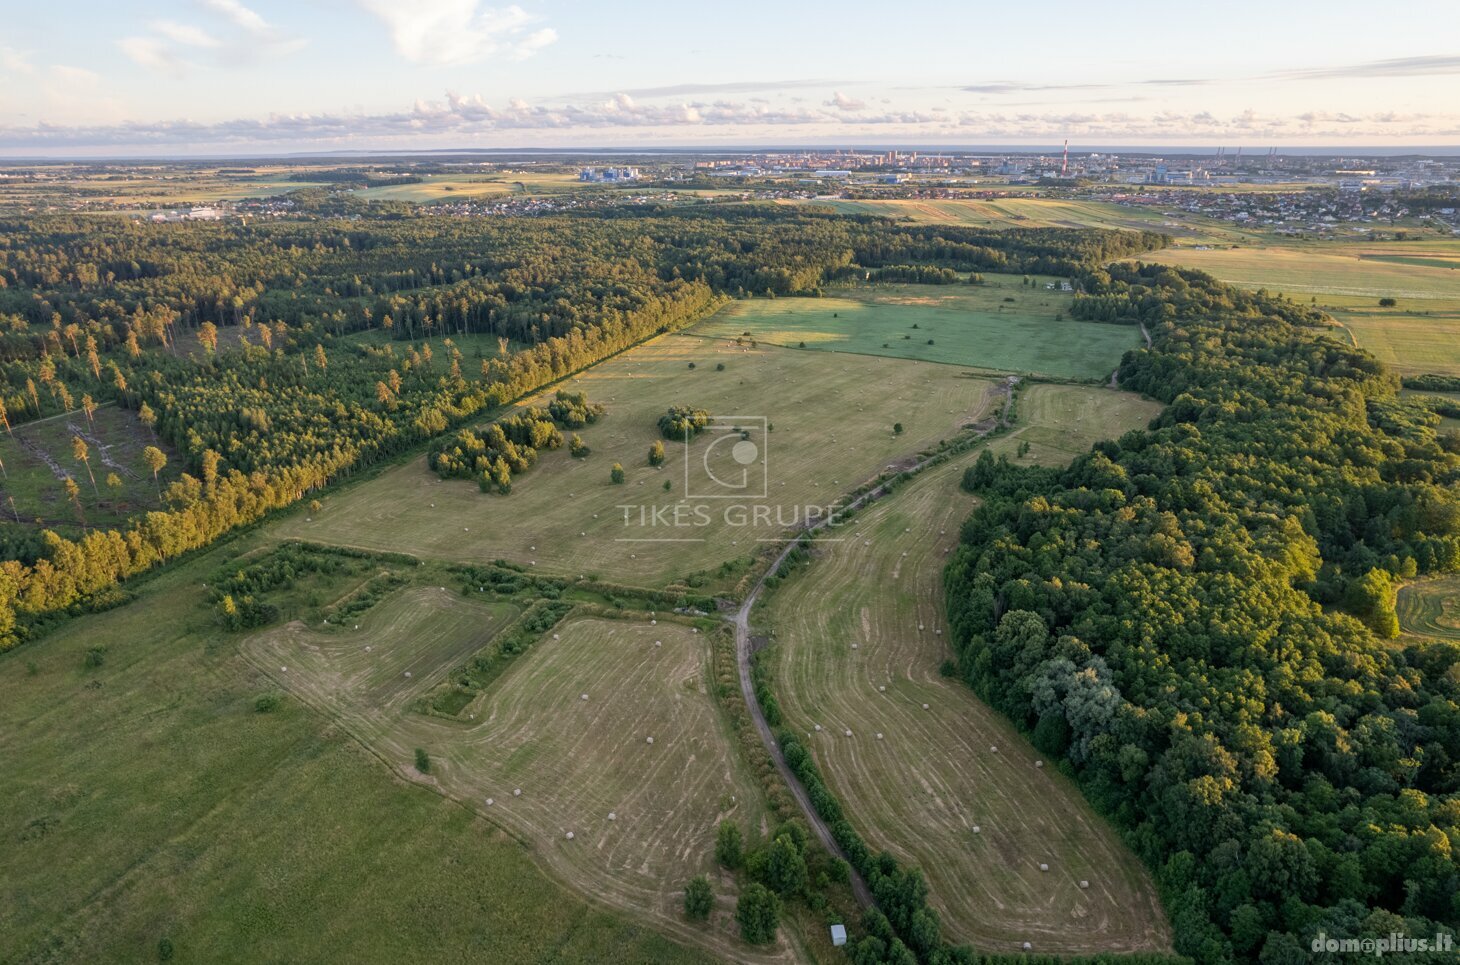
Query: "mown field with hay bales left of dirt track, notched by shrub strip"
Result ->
[[244, 587, 790, 961]]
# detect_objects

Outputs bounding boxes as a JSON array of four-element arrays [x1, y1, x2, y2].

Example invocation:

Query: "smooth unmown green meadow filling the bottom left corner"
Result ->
[[0, 550, 704, 962]]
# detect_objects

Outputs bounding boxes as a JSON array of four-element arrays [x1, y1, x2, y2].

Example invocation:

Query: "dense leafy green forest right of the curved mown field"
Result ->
[[946, 259, 1460, 962]]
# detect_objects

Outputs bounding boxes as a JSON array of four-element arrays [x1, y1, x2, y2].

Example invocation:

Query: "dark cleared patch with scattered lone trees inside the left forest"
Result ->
[[0, 406, 183, 534]]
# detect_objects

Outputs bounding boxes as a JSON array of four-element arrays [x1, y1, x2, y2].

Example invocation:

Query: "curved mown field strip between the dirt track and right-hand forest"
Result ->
[[756, 385, 1171, 955]]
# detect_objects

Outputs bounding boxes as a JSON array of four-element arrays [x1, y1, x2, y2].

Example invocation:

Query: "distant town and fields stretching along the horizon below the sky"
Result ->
[[0, 145, 1460, 235]]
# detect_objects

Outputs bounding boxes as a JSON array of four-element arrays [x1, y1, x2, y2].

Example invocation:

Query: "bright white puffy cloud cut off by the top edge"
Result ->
[[356, 0, 558, 67]]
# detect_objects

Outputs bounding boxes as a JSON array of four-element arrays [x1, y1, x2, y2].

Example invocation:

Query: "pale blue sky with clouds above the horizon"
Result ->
[[0, 0, 1460, 156]]
